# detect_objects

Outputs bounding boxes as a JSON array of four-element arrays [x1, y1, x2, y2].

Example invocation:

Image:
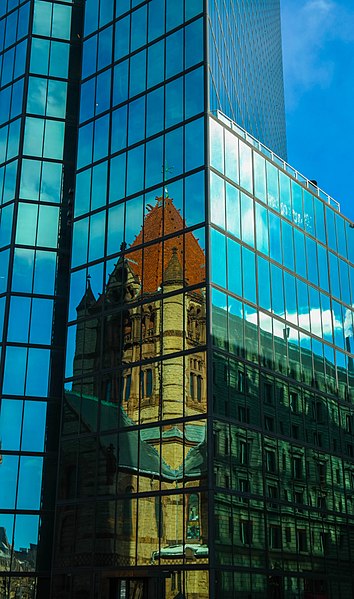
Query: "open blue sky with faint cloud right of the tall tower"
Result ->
[[281, 0, 354, 220]]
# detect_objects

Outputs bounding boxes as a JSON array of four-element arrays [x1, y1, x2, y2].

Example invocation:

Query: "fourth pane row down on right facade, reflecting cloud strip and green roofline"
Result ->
[[212, 289, 353, 400]]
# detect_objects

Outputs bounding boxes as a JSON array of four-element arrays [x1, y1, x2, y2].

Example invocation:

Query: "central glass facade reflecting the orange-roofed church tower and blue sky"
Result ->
[[52, 0, 209, 599]]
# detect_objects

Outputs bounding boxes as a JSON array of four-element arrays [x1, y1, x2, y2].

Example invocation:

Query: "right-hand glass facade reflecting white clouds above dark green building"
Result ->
[[210, 113, 354, 599]]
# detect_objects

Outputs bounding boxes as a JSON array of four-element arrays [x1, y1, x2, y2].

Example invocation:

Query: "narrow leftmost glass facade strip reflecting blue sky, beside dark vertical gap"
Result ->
[[0, 0, 79, 599]]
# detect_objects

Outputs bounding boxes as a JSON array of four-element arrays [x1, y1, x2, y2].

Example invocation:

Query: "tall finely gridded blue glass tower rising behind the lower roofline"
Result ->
[[208, 0, 287, 159]]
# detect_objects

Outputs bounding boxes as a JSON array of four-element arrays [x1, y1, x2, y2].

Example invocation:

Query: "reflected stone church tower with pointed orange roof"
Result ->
[[58, 197, 209, 599]]
